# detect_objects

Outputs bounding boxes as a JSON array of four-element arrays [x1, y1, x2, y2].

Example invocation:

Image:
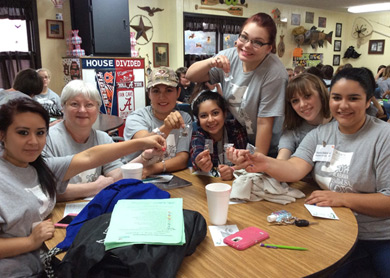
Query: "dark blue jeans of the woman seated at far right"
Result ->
[[332, 240, 390, 278]]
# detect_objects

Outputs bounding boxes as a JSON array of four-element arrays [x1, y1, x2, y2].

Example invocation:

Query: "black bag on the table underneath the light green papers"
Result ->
[[55, 210, 207, 278]]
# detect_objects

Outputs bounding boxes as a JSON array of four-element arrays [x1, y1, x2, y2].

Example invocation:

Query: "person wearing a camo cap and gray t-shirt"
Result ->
[[124, 67, 192, 177]]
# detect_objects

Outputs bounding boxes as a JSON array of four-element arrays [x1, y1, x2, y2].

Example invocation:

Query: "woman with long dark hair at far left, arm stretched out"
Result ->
[[0, 98, 165, 277]]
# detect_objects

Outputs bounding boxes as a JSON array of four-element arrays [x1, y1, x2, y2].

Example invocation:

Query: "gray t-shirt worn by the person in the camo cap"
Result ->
[[123, 106, 192, 161]]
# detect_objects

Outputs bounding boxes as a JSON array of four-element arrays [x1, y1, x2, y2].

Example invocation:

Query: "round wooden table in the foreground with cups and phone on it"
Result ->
[[46, 169, 358, 278]]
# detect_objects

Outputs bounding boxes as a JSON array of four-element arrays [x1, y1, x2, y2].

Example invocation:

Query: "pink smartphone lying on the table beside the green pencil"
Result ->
[[223, 227, 269, 250]]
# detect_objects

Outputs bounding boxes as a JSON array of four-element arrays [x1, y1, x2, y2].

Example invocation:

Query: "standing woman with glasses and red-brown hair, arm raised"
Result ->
[[186, 13, 288, 157]]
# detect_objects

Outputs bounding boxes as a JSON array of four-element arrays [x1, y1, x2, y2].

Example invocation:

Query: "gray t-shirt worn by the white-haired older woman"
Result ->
[[44, 122, 123, 184]]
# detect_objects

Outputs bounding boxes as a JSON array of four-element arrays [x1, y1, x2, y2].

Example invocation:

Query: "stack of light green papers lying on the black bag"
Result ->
[[104, 198, 185, 251]]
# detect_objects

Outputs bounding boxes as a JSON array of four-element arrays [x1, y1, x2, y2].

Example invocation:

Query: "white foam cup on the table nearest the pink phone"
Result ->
[[206, 183, 232, 225]]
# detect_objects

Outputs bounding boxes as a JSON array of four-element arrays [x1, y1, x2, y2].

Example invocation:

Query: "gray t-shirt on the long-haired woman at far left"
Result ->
[[0, 156, 73, 277]]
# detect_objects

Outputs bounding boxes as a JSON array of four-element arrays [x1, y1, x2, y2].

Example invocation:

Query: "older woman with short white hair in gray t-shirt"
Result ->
[[44, 80, 161, 201]]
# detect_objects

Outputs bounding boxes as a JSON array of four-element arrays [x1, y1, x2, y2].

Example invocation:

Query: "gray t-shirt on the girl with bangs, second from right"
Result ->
[[279, 121, 317, 153]]
